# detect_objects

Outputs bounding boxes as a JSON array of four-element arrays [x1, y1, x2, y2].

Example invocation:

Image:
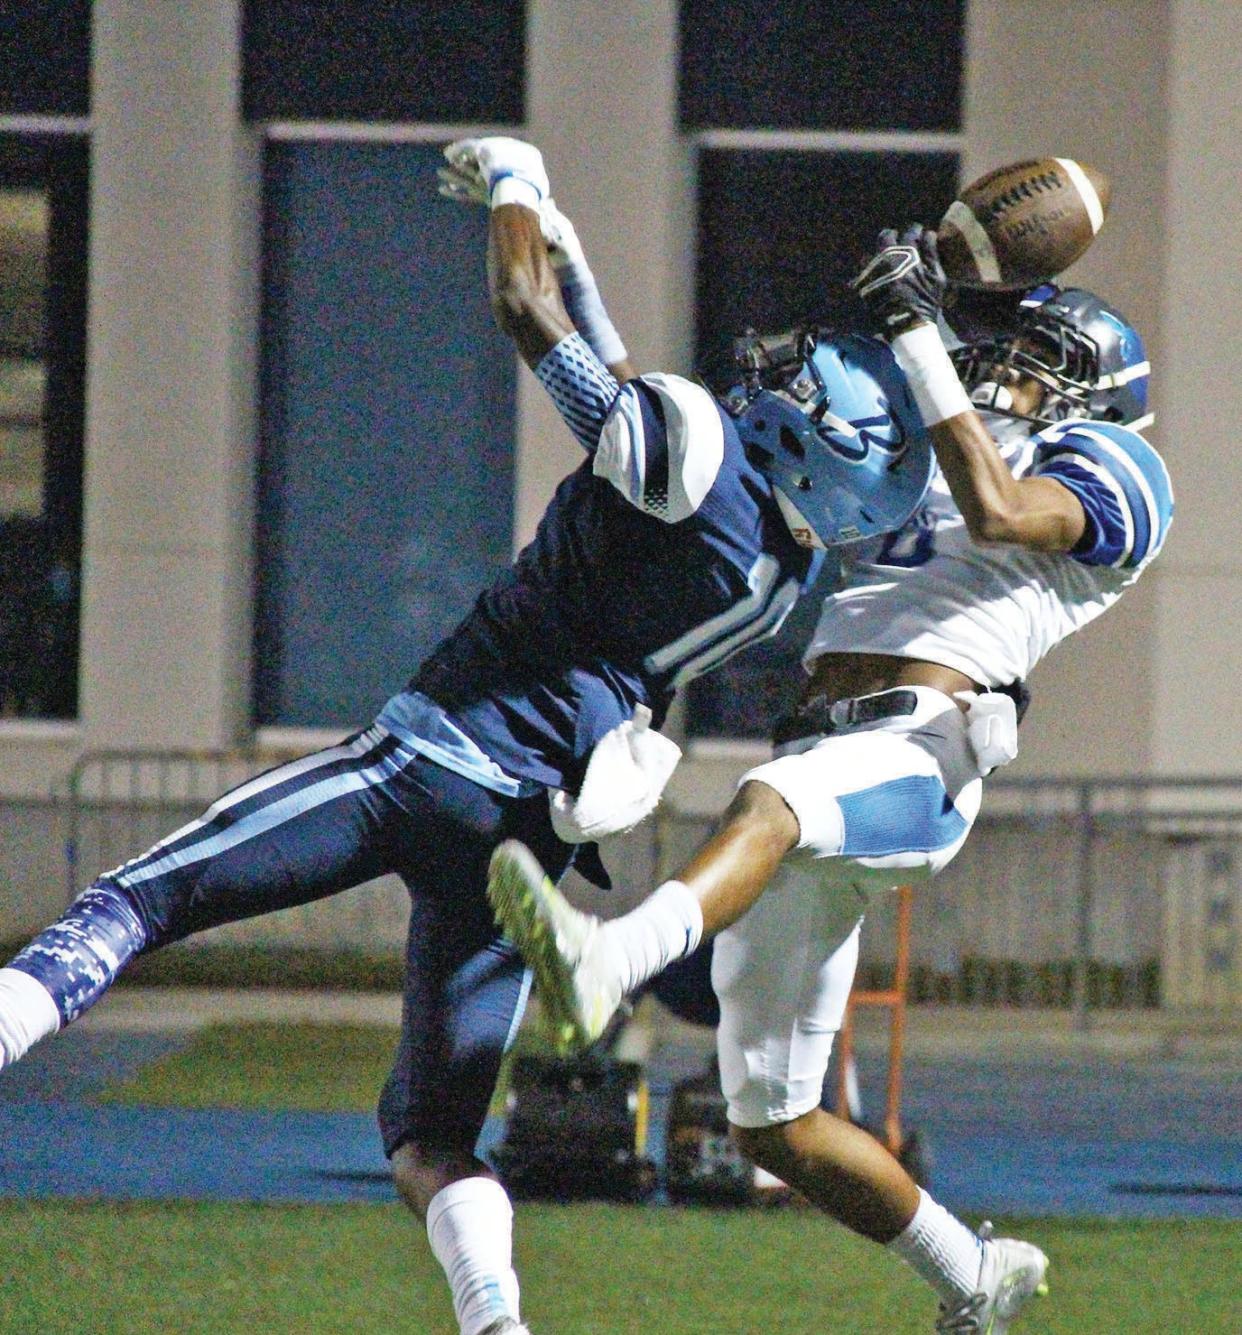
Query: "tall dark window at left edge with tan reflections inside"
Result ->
[[0, 136, 87, 718]]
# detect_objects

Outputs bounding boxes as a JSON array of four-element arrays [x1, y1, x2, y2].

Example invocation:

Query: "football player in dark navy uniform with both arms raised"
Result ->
[[0, 138, 931, 1335]]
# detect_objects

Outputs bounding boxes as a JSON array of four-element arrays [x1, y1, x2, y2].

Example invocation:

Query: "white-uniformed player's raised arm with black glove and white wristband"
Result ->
[[853, 226, 1086, 551]]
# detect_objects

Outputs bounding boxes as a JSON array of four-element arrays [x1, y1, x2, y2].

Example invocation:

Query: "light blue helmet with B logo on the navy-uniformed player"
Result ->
[[722, 331, 935, 547]]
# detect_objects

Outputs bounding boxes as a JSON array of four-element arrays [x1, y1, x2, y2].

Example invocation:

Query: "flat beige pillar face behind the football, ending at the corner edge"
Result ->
[[963, 0, 1164, 774]]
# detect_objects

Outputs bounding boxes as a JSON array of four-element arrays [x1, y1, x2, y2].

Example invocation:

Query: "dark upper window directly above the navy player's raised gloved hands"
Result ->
[[242, 0, 526, 124]]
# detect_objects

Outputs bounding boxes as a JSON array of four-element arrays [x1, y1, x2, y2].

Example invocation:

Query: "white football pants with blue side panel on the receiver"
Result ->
[[712, 686, 982, 1127]]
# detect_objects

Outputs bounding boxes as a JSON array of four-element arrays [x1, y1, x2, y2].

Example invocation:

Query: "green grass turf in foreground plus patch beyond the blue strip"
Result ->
[[0, 1025, 1242, 1335]]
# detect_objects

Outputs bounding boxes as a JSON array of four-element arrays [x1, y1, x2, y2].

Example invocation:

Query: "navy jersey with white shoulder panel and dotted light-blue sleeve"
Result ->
[[411, 335, 817, 789]]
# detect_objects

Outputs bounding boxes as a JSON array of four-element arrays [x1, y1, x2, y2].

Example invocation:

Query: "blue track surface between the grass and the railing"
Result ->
[[0, 1031, 1242, 1219]]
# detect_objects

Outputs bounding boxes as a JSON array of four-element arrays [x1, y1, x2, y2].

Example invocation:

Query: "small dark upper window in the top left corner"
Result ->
[[0, 0, 91, 116]]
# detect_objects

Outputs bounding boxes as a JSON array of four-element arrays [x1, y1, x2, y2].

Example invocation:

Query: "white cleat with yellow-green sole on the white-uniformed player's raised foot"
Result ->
[[487, 838, 621, 1052]]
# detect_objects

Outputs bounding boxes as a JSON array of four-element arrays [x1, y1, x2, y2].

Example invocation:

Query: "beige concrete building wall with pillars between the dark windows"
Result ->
[[0, 0, 1242, 930]]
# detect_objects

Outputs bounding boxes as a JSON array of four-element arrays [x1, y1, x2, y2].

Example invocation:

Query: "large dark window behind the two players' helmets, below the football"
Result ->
[[686, 150, 958, 737]]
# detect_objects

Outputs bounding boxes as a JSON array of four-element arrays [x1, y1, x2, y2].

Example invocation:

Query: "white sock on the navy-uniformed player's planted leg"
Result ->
[[427, 1177, 520, 1335]]
